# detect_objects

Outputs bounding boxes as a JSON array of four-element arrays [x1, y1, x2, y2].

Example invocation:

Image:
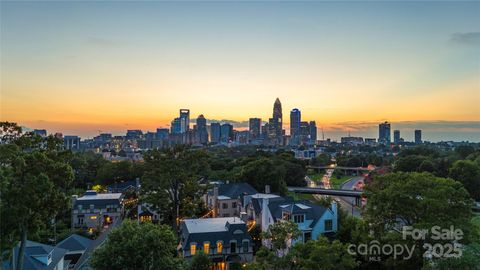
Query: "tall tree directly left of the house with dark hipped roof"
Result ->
[[142, 145, 208, 231]]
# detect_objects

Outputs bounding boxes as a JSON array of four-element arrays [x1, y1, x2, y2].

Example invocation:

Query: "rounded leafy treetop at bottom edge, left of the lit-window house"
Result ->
[[90, 220, 185, 270]]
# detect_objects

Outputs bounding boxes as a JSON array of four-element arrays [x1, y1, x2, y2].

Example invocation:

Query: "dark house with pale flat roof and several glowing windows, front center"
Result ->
[[179, 217, 253, 270]]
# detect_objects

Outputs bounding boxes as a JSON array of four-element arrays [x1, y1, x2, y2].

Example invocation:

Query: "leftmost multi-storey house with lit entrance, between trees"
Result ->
[[72, 190, 124, 230]]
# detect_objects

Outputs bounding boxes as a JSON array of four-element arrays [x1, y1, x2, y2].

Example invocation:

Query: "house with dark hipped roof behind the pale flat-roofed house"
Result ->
[[205, 183, 258, 217]]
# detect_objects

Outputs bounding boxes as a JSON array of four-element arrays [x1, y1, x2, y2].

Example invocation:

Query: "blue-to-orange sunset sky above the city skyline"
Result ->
[[0, 1, 480, 141]]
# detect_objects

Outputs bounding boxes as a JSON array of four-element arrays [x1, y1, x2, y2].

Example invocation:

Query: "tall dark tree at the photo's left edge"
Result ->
[[0, 123, 73, 269]]
